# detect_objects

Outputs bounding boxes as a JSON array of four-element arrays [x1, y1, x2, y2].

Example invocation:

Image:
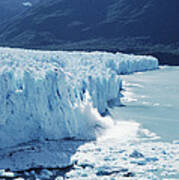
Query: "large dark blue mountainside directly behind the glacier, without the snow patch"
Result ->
[[0, 0, 179, 64]]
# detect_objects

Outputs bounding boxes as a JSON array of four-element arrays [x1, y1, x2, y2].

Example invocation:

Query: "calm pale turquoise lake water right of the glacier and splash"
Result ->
[[114, 67, 179, 141]]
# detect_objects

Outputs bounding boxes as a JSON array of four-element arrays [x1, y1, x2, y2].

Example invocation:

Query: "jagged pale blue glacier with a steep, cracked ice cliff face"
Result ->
[[0, 48, 158, 147]]
